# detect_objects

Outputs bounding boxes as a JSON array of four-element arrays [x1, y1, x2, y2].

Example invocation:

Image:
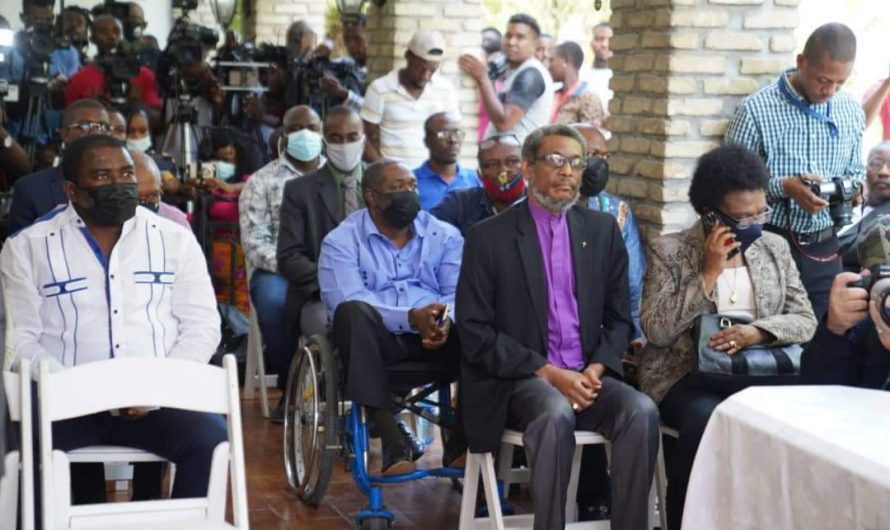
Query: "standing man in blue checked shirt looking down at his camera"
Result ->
[[724, 23, 865, 318]]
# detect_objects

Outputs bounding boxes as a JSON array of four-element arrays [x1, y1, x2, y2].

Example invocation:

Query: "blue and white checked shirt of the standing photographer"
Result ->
[[723, 69, 865, 233]]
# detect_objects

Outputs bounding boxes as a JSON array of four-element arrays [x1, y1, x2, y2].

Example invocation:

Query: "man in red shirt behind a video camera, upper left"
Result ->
[[65, 15, 161, 109]]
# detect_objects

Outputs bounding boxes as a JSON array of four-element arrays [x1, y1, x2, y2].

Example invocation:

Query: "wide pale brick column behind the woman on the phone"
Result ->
[[609, 0, 799, 239]]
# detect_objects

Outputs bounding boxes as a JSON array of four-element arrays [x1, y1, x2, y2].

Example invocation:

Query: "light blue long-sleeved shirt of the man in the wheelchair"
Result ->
[[318, 208, 464, 334]]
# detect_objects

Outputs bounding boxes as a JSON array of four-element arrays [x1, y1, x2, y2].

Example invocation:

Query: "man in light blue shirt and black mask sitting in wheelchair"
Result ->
[[318, 158, 466, 476]]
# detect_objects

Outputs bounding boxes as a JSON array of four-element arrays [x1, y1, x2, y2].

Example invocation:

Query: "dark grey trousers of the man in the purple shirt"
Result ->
[[507, 377, 658, 530]]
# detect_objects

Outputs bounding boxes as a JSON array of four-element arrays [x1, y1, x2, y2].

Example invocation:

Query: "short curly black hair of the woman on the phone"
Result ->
[[689, 145, 769, 215]]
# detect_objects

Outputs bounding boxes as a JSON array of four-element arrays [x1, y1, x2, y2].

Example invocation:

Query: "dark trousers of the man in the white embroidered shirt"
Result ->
[[53, 409, 228, 499]]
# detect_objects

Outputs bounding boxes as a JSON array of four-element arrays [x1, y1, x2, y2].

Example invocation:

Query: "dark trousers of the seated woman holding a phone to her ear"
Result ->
[[658, 376, 727, 529]]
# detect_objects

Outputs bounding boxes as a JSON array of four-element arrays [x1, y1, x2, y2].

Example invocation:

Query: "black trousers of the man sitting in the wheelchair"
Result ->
[[334, 301, 461, 408]]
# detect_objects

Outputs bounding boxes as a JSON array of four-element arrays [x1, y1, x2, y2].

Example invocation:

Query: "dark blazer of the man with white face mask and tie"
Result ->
[[276, 166, 343, 321]]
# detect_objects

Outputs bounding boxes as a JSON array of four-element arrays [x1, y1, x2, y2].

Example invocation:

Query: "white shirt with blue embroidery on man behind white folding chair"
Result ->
[[0, 204, 220, 373]]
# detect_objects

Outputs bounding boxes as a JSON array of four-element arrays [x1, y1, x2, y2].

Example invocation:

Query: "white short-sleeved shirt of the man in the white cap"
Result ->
[[361, 69, 460, 167]]
